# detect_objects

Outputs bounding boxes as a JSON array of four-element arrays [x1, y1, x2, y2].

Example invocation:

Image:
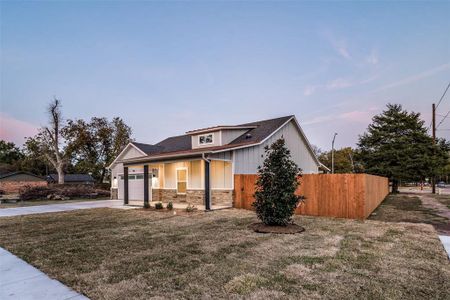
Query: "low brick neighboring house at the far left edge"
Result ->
[[0, 171, 47, 194]]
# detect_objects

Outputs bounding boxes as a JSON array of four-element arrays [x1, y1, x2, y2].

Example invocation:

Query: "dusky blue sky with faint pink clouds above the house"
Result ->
[[0, 1, 450, 150]]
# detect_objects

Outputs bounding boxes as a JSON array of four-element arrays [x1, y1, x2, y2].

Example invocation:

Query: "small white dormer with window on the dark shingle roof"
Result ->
[[186, 126, 256, 149]]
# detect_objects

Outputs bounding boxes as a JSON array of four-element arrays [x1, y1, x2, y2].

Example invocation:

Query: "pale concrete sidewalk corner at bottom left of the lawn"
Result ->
[[0, 248, 89, 300]]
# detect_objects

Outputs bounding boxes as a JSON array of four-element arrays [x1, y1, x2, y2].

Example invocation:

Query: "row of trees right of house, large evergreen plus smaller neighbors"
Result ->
[[316, 104, 450, 191]]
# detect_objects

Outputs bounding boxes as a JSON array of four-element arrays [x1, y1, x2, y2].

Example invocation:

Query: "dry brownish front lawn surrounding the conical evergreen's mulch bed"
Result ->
[[0, 209, 450, 299]]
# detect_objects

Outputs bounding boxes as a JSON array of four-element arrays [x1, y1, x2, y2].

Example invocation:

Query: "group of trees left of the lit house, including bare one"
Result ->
[[0, 99, 132, 183]]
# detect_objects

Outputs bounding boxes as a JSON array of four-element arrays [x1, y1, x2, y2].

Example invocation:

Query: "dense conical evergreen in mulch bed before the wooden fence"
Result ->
[[253, 138, 304, 226]]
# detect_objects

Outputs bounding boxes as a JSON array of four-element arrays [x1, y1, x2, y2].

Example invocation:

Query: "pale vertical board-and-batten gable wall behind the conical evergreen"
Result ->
[[234, 121, 319, 174]]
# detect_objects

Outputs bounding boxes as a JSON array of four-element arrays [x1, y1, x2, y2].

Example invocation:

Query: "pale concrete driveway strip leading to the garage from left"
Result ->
[[0, 200, 136, 217]]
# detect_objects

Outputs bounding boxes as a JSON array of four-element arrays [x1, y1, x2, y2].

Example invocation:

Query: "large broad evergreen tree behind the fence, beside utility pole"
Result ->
[[358, 104, 448, 192]]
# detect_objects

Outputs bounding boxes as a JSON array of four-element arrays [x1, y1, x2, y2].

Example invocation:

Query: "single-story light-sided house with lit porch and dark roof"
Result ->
[[109, 116, 321, 210]]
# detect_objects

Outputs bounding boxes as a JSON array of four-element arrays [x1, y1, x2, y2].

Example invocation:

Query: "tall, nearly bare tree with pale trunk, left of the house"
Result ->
[[39, 98, 65, 184]]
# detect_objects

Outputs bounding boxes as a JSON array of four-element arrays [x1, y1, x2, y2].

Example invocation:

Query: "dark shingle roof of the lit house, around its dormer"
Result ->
[[127, 116, 293, 156]]
